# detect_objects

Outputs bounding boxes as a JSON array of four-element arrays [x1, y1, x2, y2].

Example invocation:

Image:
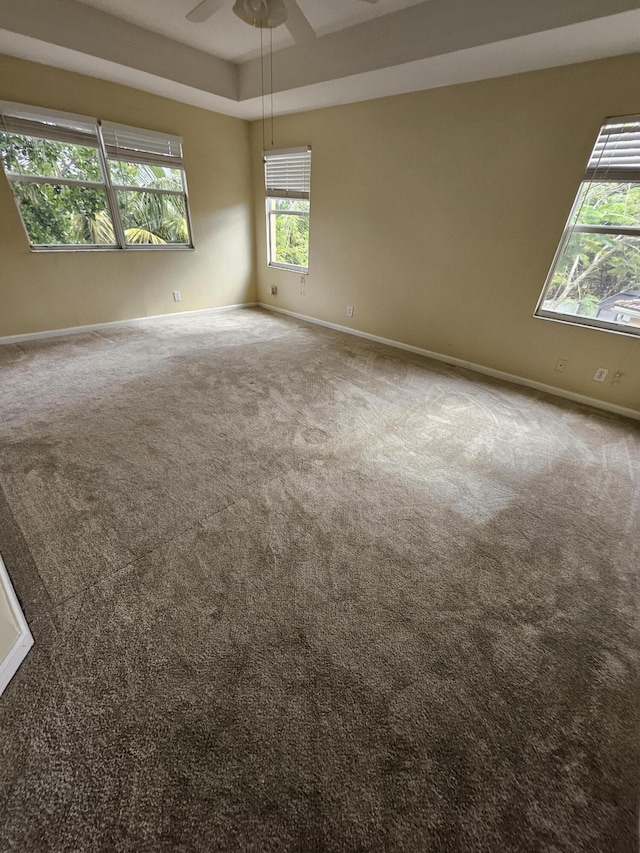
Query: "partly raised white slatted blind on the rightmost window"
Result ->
[[586, 116, 640, 182]]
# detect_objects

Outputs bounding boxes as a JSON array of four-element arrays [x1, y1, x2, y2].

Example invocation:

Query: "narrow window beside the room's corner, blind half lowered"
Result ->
[[264, 147, 311, 273]]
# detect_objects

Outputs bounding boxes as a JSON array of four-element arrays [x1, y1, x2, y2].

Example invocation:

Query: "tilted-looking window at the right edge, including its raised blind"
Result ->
[[536, 116, 640, 335]]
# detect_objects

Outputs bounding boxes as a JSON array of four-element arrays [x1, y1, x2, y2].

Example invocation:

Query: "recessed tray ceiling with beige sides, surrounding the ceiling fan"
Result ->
[[0, 0, 640, 119]]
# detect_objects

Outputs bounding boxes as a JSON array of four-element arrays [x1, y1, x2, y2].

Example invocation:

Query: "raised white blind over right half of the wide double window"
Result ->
[[100, 121, 184, 169]]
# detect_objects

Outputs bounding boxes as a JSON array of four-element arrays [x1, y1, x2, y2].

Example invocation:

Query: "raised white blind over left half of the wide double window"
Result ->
[[0, 101, 98, 148]]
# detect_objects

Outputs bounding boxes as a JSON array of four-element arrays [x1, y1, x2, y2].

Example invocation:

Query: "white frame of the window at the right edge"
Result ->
[[533, 115, 640, 337]]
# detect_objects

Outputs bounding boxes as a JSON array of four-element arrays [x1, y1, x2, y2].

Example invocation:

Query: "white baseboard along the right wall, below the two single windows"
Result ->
[[258, 302, 640, 421]]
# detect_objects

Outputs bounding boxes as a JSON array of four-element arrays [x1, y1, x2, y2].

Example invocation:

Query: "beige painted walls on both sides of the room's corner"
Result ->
[[0, 51, 640, 410]]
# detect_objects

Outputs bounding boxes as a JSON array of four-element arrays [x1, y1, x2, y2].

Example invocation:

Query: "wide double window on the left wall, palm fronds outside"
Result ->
[[0, 102, 193, 250]]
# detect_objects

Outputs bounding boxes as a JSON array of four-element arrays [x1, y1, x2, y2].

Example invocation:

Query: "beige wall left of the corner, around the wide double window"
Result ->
[[0, 56, 255, 336]]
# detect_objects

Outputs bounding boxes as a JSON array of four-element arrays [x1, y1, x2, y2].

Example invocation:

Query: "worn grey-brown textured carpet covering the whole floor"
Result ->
[[0, 310, 640, 853]]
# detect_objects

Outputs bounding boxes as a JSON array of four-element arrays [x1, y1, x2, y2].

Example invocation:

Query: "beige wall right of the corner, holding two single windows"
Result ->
[[252, 56, 640, 410]]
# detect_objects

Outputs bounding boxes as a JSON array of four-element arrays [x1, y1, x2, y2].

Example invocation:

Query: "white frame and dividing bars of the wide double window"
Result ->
[[0, 100, 195, 252]]
